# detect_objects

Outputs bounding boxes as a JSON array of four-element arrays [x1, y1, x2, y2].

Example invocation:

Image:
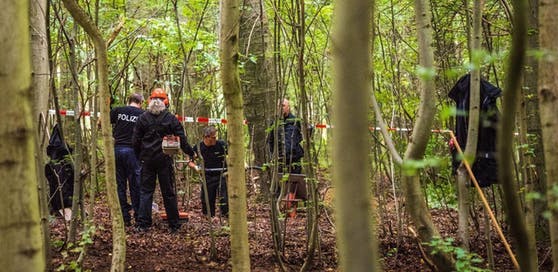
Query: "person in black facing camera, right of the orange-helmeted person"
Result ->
[[194, 126, 229, 219]]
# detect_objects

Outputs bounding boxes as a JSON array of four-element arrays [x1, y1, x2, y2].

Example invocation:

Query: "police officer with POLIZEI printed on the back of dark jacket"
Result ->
[[110, 93, 143, 226]]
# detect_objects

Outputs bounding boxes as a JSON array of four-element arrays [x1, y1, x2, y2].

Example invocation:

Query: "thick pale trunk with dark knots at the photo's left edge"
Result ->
[[0, 1, 45, 271]]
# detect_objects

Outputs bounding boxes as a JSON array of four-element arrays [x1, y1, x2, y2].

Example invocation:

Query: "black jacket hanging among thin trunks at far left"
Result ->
[[45, 125, 74, 211]]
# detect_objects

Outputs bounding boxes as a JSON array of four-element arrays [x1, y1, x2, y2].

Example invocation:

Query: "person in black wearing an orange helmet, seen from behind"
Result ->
[[132, 88, 194, 232]]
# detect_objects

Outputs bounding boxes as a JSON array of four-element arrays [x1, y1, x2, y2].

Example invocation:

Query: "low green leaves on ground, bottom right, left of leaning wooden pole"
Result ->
[[424, 237, 490, 272]]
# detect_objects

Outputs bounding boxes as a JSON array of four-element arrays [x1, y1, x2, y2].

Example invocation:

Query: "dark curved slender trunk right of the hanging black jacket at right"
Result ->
[[496, 0, 537, 271]]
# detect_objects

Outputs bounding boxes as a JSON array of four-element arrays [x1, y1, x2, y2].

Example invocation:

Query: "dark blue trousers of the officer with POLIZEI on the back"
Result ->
[[114, 146, 141, 223]]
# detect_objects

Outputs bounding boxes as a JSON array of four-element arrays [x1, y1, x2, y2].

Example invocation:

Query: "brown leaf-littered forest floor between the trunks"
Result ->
[[50, 172, 550, 272]]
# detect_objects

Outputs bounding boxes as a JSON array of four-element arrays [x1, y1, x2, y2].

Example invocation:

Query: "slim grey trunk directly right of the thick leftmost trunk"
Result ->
[[29, 0, 50, 270]]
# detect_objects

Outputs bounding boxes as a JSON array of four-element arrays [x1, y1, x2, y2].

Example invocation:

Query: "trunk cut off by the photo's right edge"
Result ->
[[538, 0, 558, 272]]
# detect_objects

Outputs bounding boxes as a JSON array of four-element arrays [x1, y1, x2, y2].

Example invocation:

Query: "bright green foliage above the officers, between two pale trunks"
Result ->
[[93, 0, 219, 103]]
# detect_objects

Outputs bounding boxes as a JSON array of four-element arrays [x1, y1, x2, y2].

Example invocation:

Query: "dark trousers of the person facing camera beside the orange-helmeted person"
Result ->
[[201, 173, 229, 217]]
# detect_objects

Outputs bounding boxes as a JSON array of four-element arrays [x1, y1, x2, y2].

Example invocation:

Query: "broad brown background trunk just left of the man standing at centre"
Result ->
[[239, 0, 274, 173]]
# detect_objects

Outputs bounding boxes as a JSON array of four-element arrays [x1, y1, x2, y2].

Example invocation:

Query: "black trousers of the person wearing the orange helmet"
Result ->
[[138, 156, 180, 229]]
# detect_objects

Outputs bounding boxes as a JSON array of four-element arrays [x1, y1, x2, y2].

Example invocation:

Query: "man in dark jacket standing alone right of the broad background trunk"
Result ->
[[267, 99, 304, 174]]
